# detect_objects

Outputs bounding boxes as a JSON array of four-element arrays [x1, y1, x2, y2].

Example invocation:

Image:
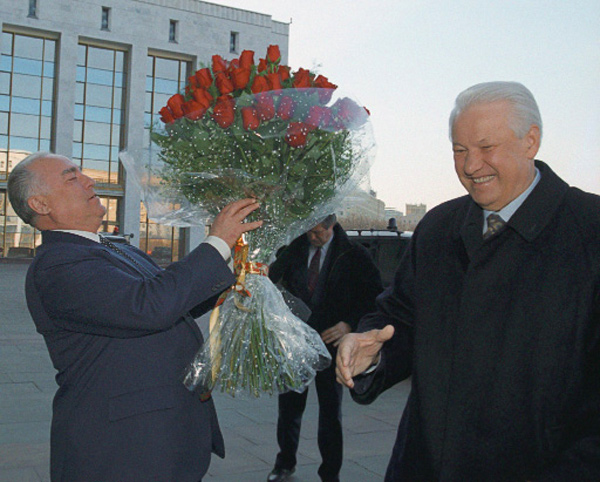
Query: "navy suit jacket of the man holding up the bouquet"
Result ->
[[26, 231, 234, 482]]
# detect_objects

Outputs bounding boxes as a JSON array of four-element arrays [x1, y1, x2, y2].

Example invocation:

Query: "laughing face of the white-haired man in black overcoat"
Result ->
[[452, 101, 540, 211]]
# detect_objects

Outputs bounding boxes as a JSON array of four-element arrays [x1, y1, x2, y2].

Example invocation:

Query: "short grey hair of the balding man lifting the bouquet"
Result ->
[[8, 152, 57, 226]]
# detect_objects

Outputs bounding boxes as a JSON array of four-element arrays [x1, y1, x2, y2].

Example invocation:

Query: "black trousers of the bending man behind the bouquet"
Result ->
[[275, 358, 343, 482]]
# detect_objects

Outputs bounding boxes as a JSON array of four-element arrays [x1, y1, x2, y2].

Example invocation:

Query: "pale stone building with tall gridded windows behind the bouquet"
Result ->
[[0, 0, 289, 263]]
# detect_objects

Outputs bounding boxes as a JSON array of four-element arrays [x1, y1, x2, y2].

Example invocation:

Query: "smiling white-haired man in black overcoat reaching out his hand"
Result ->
[[337, 82, 600, 482]]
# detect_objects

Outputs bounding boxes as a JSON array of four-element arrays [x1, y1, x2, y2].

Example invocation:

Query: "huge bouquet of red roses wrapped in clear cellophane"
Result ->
[[121, 45, 374, 395]]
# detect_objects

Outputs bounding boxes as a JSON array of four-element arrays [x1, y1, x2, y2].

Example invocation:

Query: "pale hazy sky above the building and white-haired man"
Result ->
[[211, 0, 600, 211]]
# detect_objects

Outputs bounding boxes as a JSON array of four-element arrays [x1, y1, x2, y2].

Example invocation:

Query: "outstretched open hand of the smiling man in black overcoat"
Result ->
[[335, 325, 394, 388]]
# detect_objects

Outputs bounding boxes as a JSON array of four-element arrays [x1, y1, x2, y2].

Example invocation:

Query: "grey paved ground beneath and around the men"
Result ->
[[0, 260, 409, 482]]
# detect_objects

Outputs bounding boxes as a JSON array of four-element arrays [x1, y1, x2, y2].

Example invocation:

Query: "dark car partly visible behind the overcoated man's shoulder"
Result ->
[[346, 229, 412, 287]]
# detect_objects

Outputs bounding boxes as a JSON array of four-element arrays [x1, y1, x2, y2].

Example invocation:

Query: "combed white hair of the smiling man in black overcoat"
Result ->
[[450, 81, 542, 140]]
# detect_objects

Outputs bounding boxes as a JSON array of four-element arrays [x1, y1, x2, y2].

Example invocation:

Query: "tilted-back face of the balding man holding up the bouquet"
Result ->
[[28, 157, 106, 233]]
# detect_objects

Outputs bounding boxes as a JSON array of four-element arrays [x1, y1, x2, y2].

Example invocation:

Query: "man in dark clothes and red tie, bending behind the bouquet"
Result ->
[[268, 215, 383, 482]]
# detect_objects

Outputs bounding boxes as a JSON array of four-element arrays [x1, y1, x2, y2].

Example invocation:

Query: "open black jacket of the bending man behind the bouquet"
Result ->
[[269, 224, 383, 333]]
